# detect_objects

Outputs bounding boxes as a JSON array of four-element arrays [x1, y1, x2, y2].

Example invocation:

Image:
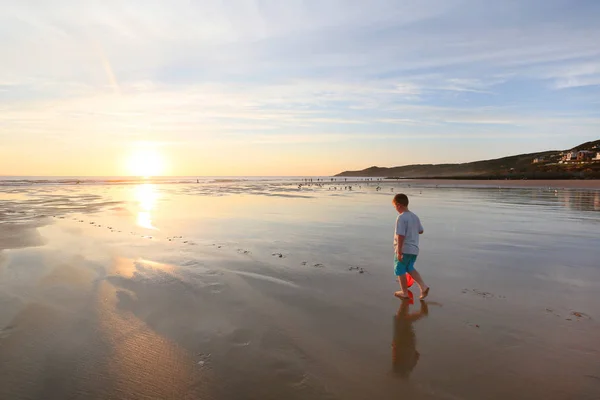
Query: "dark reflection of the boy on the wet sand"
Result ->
[[392, 291, 429, 378]]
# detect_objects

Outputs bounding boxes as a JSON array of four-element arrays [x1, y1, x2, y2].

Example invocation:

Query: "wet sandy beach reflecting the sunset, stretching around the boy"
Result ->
[[0, 180, 600, 400]]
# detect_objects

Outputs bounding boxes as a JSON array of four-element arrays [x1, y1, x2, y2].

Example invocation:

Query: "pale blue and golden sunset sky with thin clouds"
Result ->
[[0, 0, 600, 176]]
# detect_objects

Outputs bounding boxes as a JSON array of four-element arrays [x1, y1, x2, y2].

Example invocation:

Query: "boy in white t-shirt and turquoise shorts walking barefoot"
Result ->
[[392, 193, 429, 300]]
